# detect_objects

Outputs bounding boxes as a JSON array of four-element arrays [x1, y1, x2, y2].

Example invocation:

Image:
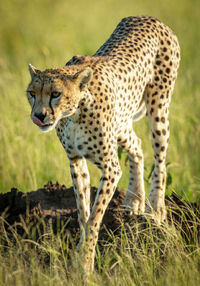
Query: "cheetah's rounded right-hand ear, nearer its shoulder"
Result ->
[[72, 67, 93, 91]]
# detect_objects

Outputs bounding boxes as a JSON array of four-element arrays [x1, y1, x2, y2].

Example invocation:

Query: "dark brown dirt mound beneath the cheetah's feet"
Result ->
[[0, 182, 200, 244]]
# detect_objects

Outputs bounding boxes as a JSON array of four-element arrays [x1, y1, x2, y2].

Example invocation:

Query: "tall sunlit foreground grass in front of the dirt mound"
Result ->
[[0, 208, 200, 286]]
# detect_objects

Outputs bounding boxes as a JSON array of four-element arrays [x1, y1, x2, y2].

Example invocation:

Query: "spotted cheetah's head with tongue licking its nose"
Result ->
[[27, 65, 92, 131]]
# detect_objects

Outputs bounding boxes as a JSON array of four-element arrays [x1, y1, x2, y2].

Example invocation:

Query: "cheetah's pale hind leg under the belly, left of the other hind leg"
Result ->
[[118, 128, 145, 214]]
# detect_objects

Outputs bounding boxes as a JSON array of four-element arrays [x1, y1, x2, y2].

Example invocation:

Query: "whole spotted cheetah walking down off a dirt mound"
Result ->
[[27, 16, 180, 273]]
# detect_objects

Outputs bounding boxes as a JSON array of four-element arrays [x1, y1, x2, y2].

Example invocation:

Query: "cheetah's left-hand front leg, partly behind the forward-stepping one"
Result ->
[[70, 158, 90, 249]]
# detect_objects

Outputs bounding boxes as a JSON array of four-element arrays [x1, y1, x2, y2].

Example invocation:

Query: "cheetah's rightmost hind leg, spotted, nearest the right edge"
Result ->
[[145, 86, 172, 225]]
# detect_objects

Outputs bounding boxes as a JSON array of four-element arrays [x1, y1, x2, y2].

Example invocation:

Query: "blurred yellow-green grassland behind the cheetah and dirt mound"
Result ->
[[0, 0, 200, 200]]
